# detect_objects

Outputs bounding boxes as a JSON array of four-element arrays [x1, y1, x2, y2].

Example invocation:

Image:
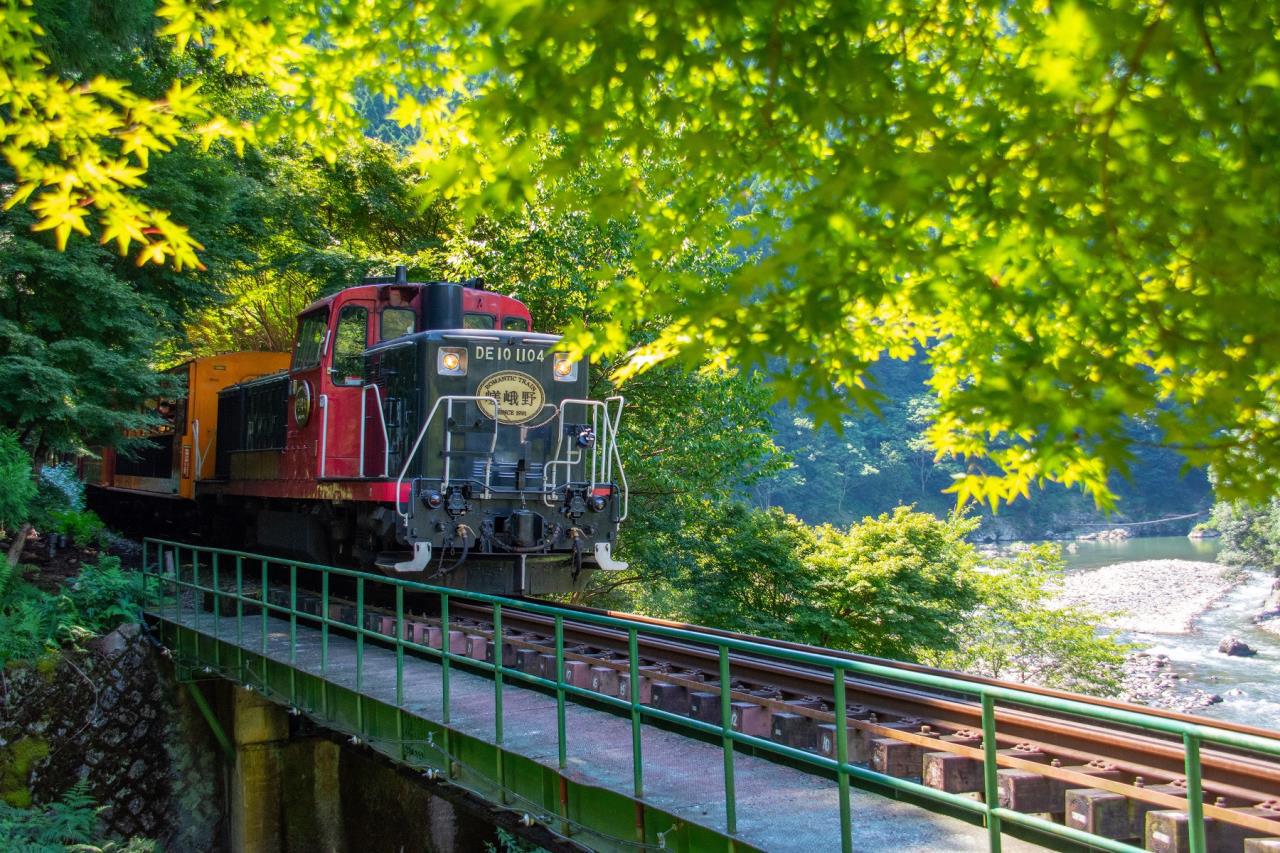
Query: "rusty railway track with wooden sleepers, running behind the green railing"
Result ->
[[206, 578, 1280, 852]]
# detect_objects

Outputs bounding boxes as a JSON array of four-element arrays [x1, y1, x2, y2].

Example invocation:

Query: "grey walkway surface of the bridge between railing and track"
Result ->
[[164, 610, 1039, 853]]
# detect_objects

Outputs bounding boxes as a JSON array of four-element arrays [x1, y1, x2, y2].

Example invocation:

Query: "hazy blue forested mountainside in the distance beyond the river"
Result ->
[[753, 359, 1212, 539]]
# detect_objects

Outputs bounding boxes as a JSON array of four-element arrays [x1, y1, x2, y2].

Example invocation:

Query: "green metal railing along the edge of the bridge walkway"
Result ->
[[142, 539, 1280, 853]]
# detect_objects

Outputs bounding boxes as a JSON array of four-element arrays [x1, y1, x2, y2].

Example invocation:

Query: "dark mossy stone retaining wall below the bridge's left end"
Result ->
[[0, 625, 223, 852]]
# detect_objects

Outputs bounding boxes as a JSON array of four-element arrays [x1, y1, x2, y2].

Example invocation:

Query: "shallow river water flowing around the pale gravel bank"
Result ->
[[1062, 537, 1280, 729]]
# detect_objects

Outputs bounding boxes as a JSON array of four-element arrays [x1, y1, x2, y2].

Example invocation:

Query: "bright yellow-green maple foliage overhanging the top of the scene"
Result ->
[[0, 0, 1280, 505]]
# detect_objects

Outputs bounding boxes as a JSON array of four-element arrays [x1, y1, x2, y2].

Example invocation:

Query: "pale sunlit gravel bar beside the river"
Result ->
[[1056, 560, 1233, 634]]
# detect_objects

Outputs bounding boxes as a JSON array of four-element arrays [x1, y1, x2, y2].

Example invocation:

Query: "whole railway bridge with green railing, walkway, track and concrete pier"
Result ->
[[140, 539, 1280, 853]]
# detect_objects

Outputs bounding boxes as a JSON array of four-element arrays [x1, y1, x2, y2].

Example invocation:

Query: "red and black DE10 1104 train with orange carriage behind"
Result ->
[[88, 268, 627, 594]]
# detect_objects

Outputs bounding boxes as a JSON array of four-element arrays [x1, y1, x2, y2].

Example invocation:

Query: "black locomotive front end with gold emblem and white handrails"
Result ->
[[366, 295, 627, 594]]
